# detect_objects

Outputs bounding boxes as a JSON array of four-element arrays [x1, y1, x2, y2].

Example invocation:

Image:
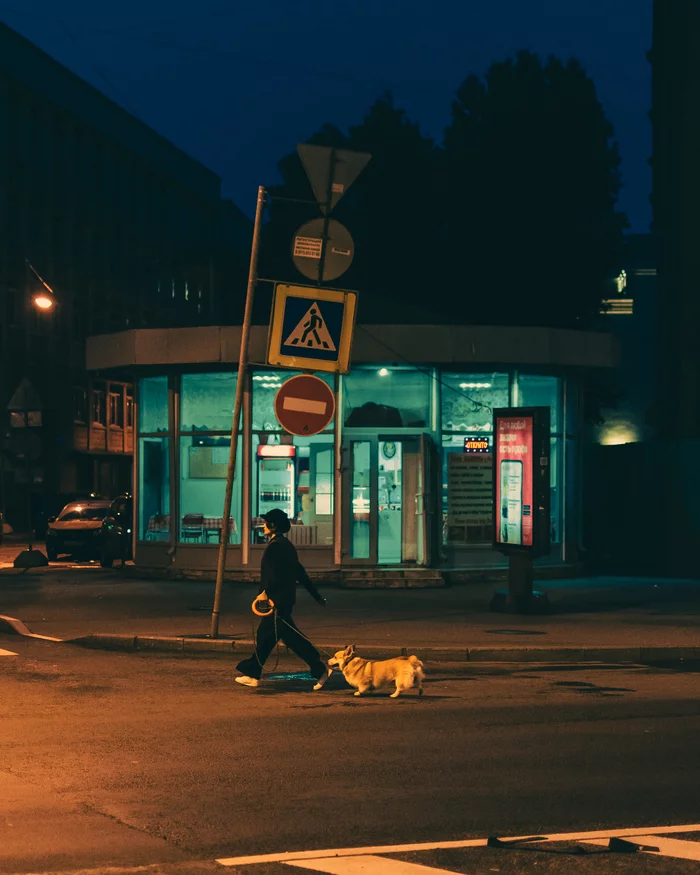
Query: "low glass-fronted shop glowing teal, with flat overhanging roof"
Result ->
[[87, 325, 616, 579]]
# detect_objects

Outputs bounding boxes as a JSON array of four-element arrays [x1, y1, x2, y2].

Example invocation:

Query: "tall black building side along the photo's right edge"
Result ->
[[636, 0, 700, 577]]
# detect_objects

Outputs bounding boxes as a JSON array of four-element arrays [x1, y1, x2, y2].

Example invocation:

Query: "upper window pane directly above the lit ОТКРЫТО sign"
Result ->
[[440, 373, 508, 432]]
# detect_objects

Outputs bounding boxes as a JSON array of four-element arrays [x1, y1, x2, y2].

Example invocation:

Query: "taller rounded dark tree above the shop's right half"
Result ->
[[444, 52, 626, 327]]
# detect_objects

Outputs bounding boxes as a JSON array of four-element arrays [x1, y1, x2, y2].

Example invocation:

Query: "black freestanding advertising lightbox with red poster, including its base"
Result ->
[[491, 407, 550, 614]]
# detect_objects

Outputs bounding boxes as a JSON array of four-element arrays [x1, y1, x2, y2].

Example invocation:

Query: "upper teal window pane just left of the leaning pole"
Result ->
[[180, 373, 238, 431]]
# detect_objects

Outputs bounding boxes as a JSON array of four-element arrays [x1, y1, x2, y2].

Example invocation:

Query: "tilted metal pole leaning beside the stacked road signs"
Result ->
[[211, 185, 265, 638]]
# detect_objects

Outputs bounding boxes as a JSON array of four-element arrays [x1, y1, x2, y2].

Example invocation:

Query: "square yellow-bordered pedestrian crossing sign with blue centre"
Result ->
[[267, 283, 357, 374]]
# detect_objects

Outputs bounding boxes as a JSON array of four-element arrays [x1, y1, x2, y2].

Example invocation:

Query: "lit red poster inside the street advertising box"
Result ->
[[494, 415, 535, 547]]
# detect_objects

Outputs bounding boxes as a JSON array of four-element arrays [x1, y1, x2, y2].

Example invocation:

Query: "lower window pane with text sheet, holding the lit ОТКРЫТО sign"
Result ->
[[442, 434, 493, 547]]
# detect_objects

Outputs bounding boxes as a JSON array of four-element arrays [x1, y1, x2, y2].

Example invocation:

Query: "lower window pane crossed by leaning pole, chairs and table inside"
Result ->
[[178, 435, 243, 544]]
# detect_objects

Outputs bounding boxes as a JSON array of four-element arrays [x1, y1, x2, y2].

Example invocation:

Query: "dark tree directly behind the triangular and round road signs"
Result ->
[[264, 95, 444, 321]]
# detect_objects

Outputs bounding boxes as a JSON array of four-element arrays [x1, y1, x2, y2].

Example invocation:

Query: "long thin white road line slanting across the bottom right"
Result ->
[[216, 823, 700, 866]]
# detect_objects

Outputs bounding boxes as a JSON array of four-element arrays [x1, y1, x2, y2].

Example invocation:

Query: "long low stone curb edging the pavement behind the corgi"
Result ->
[[65, 634, 700, 664]]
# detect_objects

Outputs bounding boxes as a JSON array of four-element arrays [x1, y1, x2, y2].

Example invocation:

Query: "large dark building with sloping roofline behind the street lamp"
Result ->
[[0, 24, 246, 527]]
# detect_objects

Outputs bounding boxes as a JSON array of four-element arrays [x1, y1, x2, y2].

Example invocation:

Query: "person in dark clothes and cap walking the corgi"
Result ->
[[235, 508, 331, 690]]
